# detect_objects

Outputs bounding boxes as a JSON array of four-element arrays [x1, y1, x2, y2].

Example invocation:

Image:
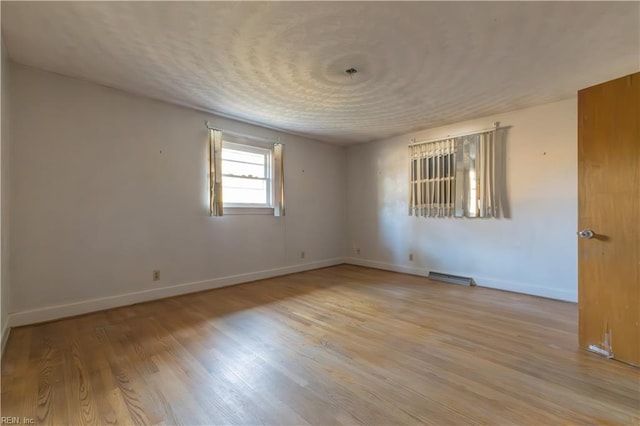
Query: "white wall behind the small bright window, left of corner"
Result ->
[[10, 63, 346, 325]]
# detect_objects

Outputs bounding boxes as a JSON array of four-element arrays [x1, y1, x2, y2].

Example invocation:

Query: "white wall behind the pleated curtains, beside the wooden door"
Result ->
[[348, 99, 578, 301]]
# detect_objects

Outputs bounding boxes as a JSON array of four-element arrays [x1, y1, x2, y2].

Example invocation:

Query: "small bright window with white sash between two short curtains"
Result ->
[[222, 140, 273, 214]]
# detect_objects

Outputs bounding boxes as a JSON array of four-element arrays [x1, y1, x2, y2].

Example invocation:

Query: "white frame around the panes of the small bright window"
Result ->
[[222, 134, 275, 216]]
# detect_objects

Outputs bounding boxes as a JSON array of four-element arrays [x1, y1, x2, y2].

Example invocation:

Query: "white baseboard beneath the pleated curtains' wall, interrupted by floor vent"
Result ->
[[344, 257, 578, 302]]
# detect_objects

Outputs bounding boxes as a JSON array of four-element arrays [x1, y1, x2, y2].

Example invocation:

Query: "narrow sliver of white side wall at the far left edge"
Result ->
[[0, 40, 9, 352]]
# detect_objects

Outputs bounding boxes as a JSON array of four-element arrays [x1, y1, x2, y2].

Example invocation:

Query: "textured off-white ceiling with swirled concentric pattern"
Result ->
[[2, 1, 640, 144]]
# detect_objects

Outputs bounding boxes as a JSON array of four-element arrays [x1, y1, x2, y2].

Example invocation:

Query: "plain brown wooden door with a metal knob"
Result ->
[[578, 73, 640, 365]]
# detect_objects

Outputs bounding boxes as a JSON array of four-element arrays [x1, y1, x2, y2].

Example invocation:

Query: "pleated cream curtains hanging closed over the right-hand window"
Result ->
[[409, 129, 499, 217]]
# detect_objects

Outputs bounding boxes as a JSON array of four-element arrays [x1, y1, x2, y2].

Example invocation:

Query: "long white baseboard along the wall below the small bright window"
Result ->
[[8, 258, 344, 328]]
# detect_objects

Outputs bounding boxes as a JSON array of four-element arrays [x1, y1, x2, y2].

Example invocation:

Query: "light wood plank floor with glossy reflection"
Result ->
[[2, 265, 640, 425]]
